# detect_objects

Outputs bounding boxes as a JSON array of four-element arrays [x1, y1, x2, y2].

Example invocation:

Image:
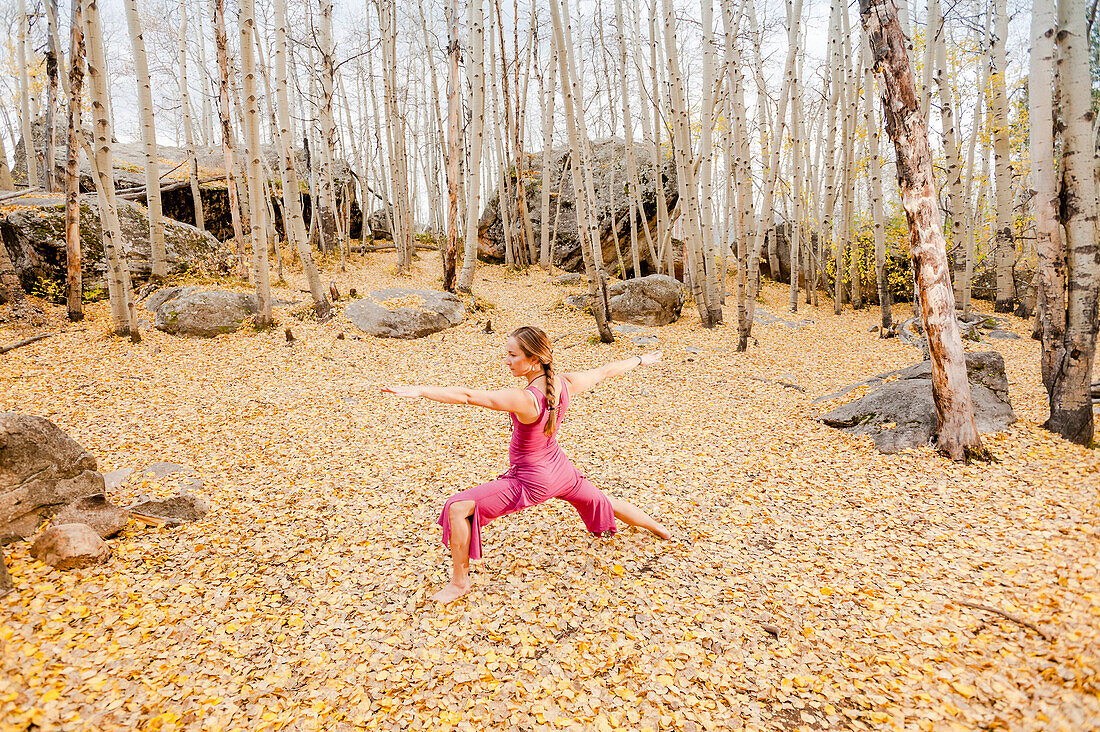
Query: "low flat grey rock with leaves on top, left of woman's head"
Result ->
[[344, 287, 466, 338]]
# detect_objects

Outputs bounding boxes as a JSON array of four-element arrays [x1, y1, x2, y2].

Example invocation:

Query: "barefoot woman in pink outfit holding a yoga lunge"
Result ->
[[382, 326, 669, 602]]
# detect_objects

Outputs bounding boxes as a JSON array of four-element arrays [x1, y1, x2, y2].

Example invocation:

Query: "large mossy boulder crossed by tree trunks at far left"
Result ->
[[0, 194, 235, 302]]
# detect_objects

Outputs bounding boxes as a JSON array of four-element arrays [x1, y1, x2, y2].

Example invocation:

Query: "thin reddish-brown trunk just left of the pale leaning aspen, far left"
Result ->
[[65, 0, 84, 323]]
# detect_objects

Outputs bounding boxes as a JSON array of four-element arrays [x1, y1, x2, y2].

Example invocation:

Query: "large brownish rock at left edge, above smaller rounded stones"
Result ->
[[0, 412, 103, 544]]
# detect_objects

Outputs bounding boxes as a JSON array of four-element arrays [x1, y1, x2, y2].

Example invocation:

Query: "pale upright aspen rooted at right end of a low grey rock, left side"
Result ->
[[240, 0, 272, 328]]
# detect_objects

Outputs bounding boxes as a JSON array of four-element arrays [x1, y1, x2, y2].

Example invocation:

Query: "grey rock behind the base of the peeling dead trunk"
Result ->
[[814, 351, 1016, 452]]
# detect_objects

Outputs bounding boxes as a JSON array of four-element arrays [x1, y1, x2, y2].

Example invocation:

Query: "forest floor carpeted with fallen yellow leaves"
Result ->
[[0, 253, 1100, 730]]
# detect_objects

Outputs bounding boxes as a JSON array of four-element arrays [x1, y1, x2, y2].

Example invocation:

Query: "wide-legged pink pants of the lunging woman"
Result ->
[[439, 470, 616, 559]]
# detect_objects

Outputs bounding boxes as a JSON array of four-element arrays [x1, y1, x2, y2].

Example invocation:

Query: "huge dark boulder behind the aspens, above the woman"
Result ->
[[477, 140, 679, 274]]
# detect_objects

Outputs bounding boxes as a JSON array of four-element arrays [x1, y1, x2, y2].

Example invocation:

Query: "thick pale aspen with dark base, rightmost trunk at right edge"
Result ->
[[1044, 0, 1100, 445]]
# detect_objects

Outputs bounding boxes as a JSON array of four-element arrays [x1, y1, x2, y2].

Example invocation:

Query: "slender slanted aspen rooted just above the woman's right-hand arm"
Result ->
[[550, 0, 615, 343]]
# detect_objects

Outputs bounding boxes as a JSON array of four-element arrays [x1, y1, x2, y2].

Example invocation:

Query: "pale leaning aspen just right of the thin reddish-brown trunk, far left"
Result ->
[[81, 0, 141, 342]]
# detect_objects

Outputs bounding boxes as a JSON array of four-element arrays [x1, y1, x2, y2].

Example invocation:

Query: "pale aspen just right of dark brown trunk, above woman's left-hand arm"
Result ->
[[458, 0, 488, 293]]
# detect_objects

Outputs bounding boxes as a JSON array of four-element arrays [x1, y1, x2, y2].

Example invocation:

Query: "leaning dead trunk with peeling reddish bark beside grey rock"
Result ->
[[859, 0, 988, 460]]
